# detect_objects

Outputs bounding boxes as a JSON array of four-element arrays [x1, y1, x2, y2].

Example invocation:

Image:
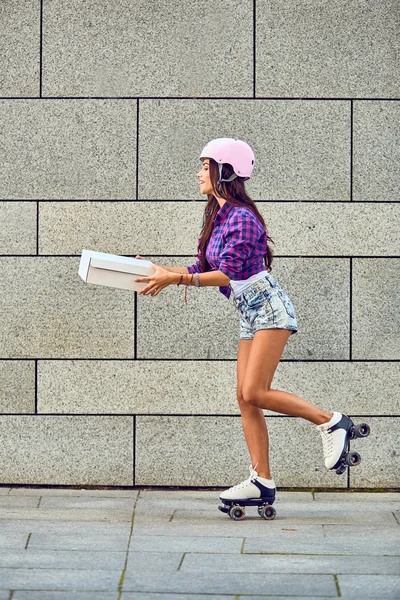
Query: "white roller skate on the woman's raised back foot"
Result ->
[[314, 412, 371, 475]]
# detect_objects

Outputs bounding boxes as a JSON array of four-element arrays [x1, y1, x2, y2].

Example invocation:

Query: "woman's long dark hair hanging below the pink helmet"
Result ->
[[198, 158, 275, 272]]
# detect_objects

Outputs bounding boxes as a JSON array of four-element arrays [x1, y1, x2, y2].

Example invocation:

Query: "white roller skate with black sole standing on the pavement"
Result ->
[[218, 463, 276, 521]]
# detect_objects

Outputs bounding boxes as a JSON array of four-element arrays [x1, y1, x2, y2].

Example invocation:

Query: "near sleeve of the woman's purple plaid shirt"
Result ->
[[218, 211, 258, 280]]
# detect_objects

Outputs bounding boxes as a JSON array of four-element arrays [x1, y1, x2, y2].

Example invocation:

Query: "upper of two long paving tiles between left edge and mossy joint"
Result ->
[[0, 545, 126, 574]]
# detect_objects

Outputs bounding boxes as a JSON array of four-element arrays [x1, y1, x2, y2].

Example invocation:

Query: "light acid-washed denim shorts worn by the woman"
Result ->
[[231, 273, 298, 340]]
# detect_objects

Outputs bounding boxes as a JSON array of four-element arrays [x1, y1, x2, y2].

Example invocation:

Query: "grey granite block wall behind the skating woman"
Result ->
[[0, 0, 400, 489]]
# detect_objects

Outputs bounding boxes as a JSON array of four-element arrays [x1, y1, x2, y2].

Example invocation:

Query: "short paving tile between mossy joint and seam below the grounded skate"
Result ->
[[129, 534, 243, 554]]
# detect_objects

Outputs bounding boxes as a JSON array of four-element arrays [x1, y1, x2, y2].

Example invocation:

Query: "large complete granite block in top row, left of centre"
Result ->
[[43, 0, 253, 97]]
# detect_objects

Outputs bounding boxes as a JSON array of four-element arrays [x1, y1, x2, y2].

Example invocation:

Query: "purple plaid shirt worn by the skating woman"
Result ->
[[187, 202, 267, 298]]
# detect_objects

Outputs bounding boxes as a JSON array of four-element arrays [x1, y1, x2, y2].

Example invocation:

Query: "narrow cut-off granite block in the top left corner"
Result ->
[[0, 0, 40, 97]]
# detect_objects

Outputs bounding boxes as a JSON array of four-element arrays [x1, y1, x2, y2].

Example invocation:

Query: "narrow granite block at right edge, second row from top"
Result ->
[[353, 100, 400, 199]]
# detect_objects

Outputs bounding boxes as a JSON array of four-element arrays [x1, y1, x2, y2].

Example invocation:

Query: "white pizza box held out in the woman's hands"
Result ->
[[78, 250, 155, 291]]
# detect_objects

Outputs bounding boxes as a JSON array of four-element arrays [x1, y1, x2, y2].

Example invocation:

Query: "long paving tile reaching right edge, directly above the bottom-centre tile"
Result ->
[[179, 553, 400, 575]]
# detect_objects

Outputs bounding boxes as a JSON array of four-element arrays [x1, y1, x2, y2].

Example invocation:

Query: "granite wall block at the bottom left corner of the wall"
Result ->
[[0, 416, 133, 488]]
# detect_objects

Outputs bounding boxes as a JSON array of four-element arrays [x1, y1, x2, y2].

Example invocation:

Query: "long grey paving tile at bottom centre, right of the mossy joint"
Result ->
[[124, 571, 337, 597]]
